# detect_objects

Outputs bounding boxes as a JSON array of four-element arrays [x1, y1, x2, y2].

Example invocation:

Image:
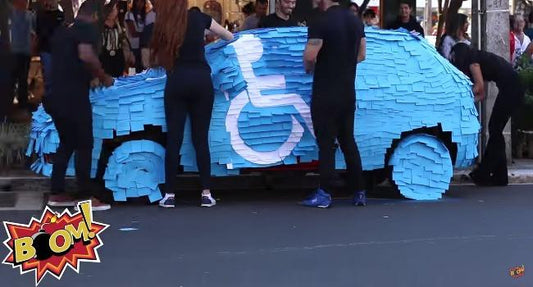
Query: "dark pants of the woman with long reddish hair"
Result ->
[[165, 66, 214, 193]]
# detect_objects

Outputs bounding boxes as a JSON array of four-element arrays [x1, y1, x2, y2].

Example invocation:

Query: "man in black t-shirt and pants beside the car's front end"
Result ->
[[43, 0, 113, 210]]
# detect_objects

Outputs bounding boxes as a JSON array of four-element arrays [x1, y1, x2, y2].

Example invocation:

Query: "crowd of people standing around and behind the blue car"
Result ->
[[0, 0, 533, 210]]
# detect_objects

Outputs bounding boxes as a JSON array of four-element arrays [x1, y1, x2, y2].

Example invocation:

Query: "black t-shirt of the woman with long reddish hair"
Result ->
[[176, 10, 213, 67]]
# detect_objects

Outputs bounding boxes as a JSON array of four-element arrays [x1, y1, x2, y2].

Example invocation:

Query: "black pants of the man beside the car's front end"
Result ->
[[52, 113, 94, 196]]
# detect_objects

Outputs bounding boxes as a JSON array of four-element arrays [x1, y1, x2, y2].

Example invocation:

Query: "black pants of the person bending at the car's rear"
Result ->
[[476, 75, 524, 185]]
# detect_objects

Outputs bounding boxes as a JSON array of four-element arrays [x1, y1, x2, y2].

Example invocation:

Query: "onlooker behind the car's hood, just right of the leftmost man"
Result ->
[[100, 1, 126, 77]]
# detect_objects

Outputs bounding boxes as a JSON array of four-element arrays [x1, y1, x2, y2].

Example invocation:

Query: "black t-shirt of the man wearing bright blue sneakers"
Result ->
[[308, 6, 365, 98]]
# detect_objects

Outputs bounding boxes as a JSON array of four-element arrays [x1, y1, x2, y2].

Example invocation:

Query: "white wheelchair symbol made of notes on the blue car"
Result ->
[[226, 35, 314, 164]]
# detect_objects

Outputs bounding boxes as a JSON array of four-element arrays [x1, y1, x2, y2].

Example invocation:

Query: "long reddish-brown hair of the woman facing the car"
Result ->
[[151, 0, 188, 71]]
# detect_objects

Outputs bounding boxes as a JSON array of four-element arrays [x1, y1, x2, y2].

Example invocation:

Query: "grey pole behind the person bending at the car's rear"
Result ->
[[472, 0, 512, 163]]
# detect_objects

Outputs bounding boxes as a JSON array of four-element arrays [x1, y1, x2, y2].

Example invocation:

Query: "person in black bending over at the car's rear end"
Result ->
[[450, 43, 524, 186]]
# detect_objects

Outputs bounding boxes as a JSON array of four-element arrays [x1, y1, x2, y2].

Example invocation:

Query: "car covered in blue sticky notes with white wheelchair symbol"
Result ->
[[28, 27, 480, 201]]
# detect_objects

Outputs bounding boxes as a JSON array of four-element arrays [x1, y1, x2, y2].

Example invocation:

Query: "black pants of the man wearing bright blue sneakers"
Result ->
[[311, 95, 365, 192]]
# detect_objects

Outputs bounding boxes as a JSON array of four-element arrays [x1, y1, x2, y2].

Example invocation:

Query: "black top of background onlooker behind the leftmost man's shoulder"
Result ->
[[36, 10, 65, 53]]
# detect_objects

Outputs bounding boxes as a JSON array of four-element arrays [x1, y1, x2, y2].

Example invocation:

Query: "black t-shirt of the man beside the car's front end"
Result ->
[[45, 20, 99, 115]]
